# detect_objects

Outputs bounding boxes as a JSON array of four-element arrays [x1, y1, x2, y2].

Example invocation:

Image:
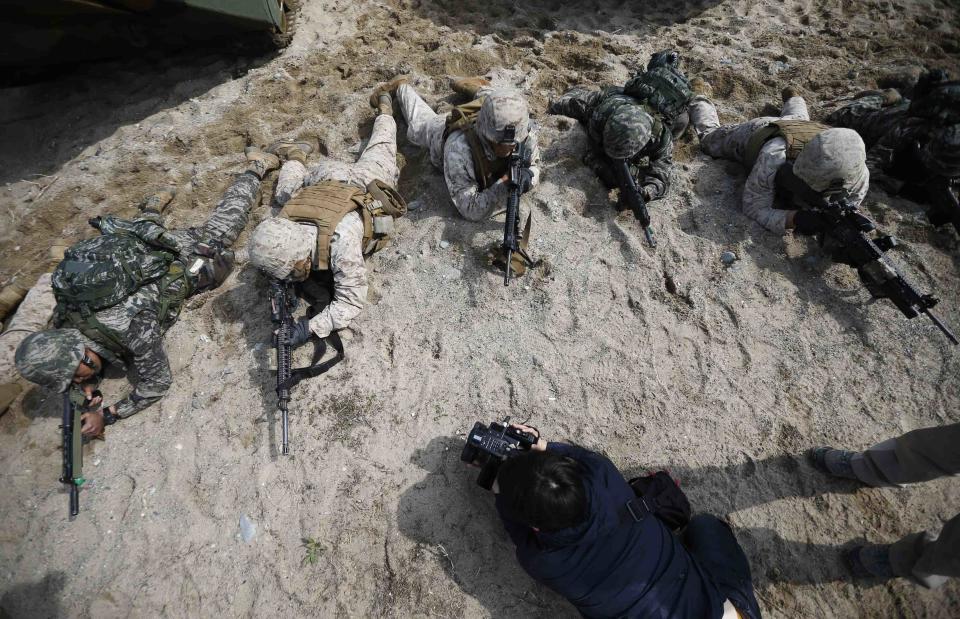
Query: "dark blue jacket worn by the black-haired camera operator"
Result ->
[[497, 443, 724, 619]]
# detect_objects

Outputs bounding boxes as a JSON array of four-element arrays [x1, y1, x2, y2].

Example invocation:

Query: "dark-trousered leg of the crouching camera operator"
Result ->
[[683, 514, 760, 619]]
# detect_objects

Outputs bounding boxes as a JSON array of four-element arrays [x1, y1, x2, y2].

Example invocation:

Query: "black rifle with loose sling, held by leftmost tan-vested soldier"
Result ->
[[270, 280, 344, 455]]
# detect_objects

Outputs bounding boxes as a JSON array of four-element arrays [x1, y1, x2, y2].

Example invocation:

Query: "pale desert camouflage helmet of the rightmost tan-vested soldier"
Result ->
[[793, 128, 870, 192]]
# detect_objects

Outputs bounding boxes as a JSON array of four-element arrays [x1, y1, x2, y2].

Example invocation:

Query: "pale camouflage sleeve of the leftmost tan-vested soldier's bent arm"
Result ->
[[310, 211, 367, 338]]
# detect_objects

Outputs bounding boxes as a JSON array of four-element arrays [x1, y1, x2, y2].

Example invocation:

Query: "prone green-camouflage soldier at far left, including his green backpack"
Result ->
[[15, 149, 280, 437]]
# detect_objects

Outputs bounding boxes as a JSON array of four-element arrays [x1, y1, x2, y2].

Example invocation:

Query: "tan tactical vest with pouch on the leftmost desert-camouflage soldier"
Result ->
[[280, 180, 407, 271]]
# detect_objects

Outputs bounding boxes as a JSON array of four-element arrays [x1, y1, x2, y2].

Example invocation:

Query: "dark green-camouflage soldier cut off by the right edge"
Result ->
[[827, 71, 960, 232]]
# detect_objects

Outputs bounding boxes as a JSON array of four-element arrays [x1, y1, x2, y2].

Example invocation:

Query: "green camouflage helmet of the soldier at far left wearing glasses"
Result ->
[[14, 329, 86, 393]]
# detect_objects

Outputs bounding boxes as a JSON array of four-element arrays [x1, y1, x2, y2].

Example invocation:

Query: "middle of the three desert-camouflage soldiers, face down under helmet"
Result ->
[[374, 77, 540, 221]]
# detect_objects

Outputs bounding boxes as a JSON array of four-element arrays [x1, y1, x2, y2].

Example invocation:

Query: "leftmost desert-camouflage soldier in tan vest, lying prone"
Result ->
[[249, 93, 406, 346]]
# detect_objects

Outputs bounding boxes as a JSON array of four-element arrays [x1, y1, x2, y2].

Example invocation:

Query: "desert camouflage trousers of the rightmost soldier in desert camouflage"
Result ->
[[689, 96, 810, 163]]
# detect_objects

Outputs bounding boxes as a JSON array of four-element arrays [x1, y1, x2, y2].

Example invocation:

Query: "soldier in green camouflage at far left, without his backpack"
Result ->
[[16, 151, 280, 436]]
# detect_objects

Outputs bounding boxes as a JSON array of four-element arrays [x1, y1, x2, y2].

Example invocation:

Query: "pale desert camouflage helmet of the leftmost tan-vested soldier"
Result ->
[[247, 217, 317, 279]]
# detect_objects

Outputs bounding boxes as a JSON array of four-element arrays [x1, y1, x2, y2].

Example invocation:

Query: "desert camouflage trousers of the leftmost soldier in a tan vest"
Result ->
[[274, 114, 400, 206]]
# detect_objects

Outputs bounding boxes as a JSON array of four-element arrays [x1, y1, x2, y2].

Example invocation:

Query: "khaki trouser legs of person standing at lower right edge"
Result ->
[[850, 423, 960, 587]]
